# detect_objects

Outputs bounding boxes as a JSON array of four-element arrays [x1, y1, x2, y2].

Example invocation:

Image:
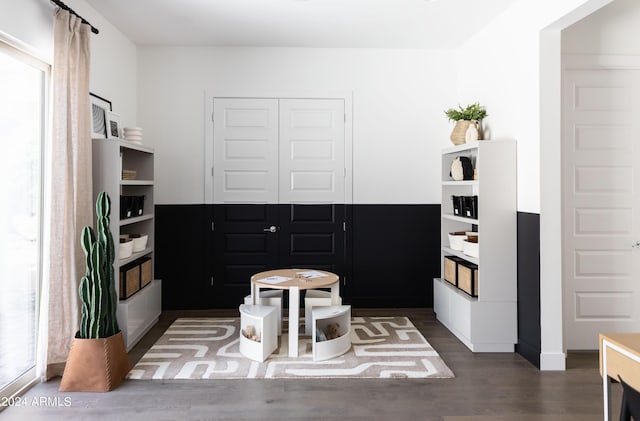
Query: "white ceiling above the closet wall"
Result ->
[[82, 0, 518, 49]]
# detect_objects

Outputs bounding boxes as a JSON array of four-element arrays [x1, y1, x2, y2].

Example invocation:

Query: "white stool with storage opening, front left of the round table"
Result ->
[[239, 304, 278, 362]]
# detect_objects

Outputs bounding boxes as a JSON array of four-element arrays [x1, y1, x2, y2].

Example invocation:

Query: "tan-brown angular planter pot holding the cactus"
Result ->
[[60, 332, 131, 392]]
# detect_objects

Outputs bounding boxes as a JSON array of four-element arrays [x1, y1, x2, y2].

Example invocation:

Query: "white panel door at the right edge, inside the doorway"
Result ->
[[564, 70, 640, 350]]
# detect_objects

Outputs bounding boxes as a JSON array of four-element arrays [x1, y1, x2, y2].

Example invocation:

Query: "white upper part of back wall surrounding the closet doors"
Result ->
[[138, 46, 456, 204]]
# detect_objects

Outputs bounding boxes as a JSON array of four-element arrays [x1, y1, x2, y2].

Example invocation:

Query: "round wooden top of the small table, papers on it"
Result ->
[[251, 269, 340, 289]]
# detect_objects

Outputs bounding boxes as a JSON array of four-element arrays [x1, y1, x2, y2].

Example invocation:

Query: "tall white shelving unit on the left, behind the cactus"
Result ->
[[93, 139, 162, 350]]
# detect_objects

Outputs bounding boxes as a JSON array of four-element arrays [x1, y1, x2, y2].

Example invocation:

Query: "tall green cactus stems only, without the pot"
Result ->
[[79, 192, 120, 339]]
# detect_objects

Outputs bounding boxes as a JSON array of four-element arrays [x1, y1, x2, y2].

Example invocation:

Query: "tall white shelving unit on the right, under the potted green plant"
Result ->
[[433, 140, 518, 352]]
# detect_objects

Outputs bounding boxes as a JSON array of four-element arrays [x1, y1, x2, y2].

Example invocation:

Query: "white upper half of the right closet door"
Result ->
[[279, 99, 345, 204]]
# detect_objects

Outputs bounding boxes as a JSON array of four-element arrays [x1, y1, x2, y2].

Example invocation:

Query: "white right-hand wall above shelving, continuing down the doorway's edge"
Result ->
[[459, 0, 611, 370]]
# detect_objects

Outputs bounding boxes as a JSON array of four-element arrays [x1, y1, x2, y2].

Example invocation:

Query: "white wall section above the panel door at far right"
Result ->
[[562, 0, 640, 56]]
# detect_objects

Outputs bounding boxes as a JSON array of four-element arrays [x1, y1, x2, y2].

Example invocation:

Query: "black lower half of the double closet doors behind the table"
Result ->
[[212, 204, 345, 308]]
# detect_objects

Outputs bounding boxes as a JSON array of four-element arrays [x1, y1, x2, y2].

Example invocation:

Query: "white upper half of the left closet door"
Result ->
[[213, 98, 278, 203]]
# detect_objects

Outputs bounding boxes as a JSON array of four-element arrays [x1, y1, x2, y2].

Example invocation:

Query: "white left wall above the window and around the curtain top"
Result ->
[[0, 0, 137, 124]]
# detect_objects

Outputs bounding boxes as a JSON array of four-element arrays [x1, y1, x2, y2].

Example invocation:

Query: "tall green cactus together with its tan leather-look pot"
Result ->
[[60, 192, 131, 392]]
